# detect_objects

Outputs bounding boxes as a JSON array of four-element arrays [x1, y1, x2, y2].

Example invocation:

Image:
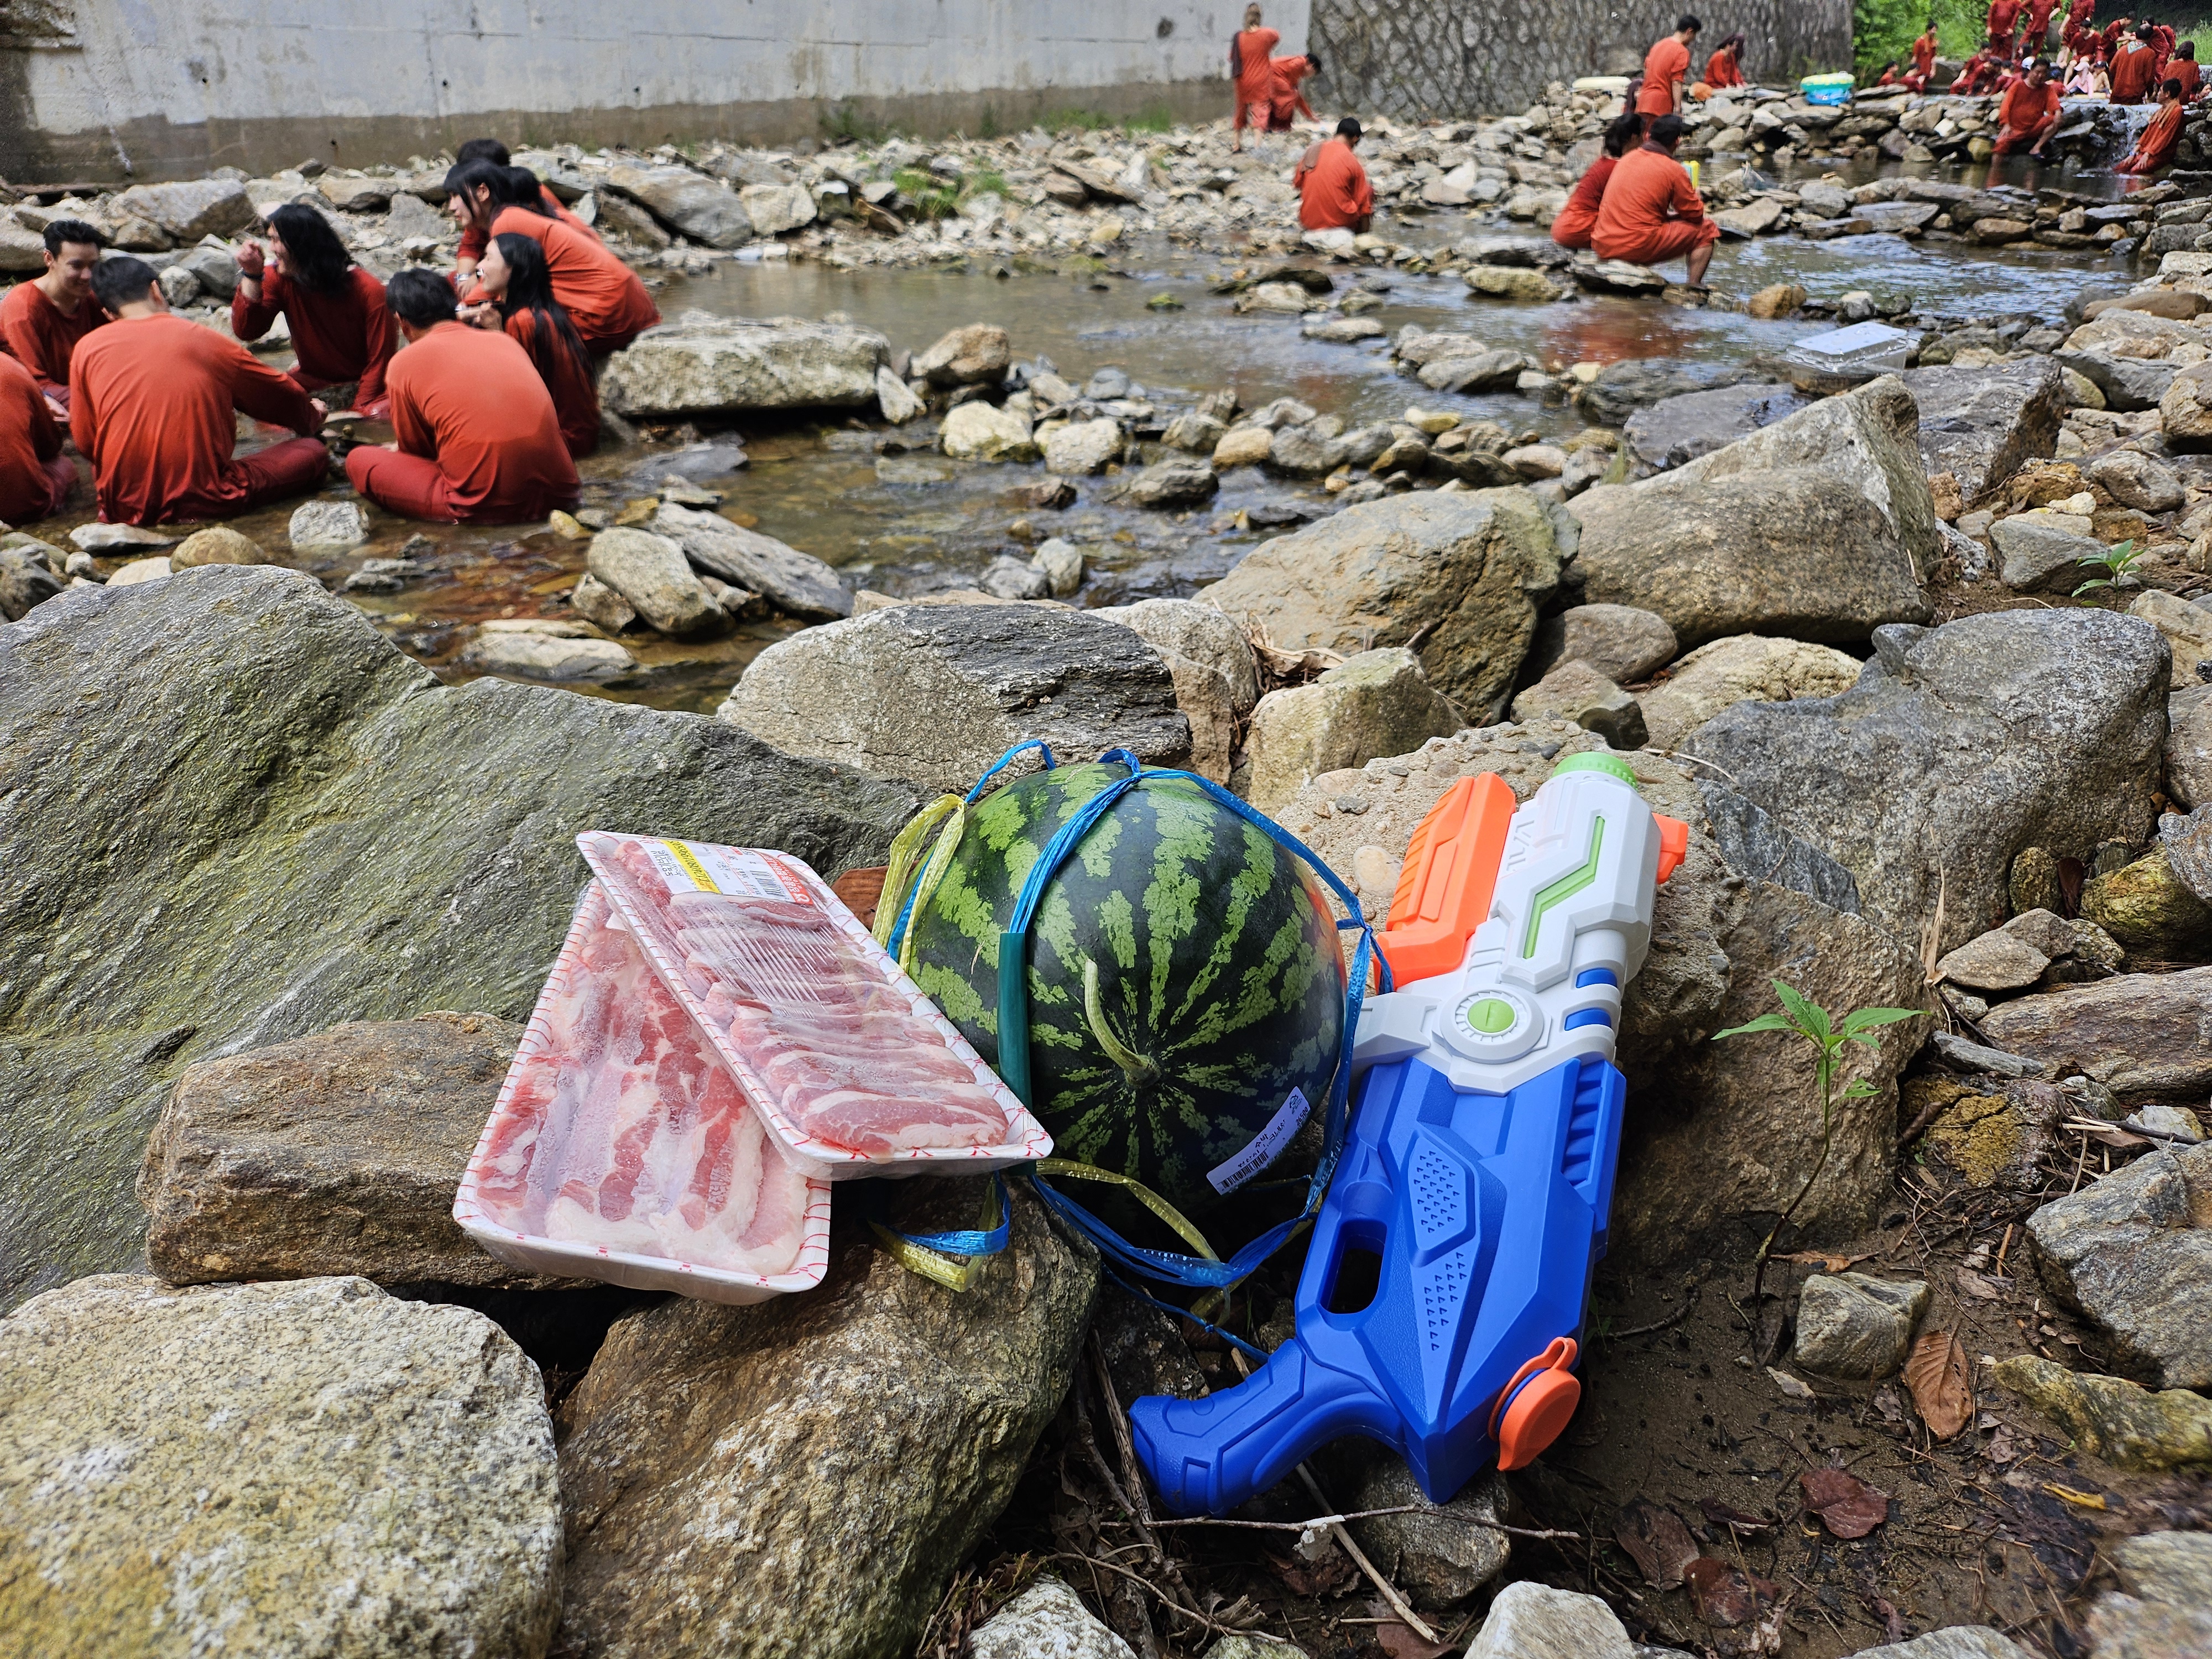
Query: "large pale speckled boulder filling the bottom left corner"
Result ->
[[0, 1274, 562, 1659]]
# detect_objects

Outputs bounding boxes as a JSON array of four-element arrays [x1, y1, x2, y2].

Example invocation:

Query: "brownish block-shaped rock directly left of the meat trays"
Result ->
[[139, 1013, 542, 1285]]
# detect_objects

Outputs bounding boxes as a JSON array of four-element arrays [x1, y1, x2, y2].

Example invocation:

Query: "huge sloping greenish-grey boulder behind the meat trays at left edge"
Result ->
[[0, 564, 916, 1305]]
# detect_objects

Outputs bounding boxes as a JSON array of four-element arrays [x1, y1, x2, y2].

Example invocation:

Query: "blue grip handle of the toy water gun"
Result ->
[[1128, 1336, 1398, 1515]]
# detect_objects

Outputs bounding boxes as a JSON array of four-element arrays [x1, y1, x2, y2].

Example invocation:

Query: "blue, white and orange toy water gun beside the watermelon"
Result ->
[[1130, 752, 1690, 1515]]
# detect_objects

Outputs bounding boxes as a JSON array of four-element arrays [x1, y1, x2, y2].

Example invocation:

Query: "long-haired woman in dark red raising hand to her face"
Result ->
[[230, 204, 398, 420]]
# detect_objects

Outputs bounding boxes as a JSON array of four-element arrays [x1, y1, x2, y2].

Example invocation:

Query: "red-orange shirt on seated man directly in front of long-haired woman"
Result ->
[[385, 323, 577, 522]]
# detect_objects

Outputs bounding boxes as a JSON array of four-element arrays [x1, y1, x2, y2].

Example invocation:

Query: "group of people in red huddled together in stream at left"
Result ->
[[0, 139, 661, 540]]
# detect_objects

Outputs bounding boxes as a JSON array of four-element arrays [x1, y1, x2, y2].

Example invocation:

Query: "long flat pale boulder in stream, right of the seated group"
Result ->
[[599, 312, 891, 416]]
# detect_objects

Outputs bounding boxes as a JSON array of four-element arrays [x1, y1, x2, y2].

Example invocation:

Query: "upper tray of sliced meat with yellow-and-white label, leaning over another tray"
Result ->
[[577, 832, 1051, 1179]]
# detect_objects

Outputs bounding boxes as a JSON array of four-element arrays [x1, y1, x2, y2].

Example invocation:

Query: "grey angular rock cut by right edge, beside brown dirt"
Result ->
[[2028, 1141, 2212, 1389]]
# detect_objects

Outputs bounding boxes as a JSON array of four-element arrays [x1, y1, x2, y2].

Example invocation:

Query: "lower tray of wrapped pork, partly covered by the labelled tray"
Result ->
[[453, 883, 830, 1301]]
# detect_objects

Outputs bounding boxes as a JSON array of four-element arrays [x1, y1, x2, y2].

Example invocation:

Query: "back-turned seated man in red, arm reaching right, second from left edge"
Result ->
[[69, 259, 330, 524]]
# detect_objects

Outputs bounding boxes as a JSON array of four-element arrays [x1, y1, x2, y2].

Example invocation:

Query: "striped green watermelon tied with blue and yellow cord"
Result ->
[[909, 763, 1345, 1219]]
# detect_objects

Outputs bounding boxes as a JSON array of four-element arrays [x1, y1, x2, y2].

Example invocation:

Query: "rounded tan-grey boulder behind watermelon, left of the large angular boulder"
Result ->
[[1203, 489, 1559, 719]]
